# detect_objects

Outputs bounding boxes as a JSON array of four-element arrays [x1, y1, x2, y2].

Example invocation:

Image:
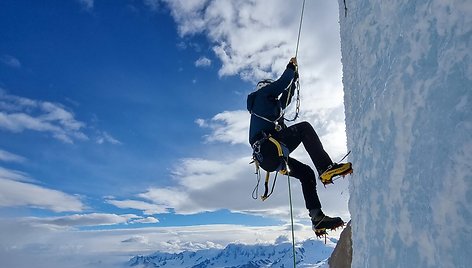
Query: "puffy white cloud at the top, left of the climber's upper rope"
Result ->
[[162, 0, 299, 80]]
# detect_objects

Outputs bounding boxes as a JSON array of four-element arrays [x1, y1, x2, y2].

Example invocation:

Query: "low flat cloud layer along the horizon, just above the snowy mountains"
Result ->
[[0, 219, 328, 268]]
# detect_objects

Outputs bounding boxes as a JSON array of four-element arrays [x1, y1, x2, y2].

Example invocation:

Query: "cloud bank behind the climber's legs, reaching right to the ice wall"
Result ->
[[113, 148, 349, 220]]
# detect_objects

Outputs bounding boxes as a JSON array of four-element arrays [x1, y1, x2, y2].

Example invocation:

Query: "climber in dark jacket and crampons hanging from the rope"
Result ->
[[247, 57, 352, 236]]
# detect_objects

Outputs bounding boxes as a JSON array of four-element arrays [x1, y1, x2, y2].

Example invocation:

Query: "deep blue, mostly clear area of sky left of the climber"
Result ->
[[0, 1, 260, 224]]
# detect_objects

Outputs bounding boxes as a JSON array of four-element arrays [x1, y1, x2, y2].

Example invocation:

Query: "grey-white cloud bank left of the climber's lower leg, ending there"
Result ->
[[114, 157, 306, 217]]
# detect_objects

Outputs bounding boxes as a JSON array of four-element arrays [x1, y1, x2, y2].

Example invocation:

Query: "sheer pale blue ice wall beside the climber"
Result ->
[[338, 0, 472, 267]]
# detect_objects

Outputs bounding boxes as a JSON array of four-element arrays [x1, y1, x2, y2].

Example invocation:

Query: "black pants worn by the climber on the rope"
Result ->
[[274, 122, 333, 210]]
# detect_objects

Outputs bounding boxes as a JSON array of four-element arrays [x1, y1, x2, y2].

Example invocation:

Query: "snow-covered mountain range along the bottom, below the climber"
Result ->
[[128, 239, 337, 268]]
